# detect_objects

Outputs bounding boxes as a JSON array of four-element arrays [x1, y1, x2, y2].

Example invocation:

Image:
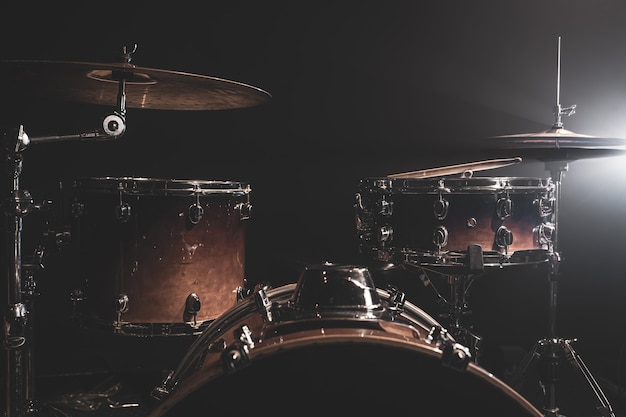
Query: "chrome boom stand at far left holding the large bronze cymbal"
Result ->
[[3, 49, 134, 417]]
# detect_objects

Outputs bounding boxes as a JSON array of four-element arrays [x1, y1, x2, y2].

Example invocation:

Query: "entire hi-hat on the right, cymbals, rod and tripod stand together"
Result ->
[[488, 37, 626, 417]]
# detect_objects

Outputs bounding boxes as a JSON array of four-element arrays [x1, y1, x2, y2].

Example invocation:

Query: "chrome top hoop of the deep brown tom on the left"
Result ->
[[74, 177, 251, 195]]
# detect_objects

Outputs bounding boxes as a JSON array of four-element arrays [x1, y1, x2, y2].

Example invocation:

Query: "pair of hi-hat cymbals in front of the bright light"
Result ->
[[489, 127, 626, 160]]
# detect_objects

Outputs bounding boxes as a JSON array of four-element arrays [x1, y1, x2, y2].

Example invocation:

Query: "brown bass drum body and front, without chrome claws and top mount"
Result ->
[[148, 284, 541, 417]]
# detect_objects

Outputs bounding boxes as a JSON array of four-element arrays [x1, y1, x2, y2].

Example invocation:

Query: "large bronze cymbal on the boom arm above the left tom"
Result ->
[[0, 60, 271, 110]]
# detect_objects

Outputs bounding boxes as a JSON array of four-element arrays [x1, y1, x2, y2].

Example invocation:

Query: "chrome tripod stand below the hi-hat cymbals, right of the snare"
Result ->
[[510, 161, 615, 417]]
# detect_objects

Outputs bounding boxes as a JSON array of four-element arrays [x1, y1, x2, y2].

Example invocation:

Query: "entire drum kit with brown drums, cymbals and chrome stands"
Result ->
[[0, 39, 626, 417]]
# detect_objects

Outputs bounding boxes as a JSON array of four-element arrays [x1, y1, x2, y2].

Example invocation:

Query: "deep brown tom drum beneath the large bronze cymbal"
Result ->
[[73, 177, 251, 336]]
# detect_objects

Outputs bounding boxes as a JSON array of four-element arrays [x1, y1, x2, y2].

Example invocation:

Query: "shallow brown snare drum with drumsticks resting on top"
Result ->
[[356, 177, 555, 260]]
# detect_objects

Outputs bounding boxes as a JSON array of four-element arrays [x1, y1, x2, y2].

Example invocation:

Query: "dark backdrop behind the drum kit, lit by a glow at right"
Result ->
[[0, 0, 626, 412]]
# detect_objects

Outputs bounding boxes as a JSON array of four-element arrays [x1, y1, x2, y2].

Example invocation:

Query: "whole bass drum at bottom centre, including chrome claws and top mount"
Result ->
[[148, 264, 542, 417]]
